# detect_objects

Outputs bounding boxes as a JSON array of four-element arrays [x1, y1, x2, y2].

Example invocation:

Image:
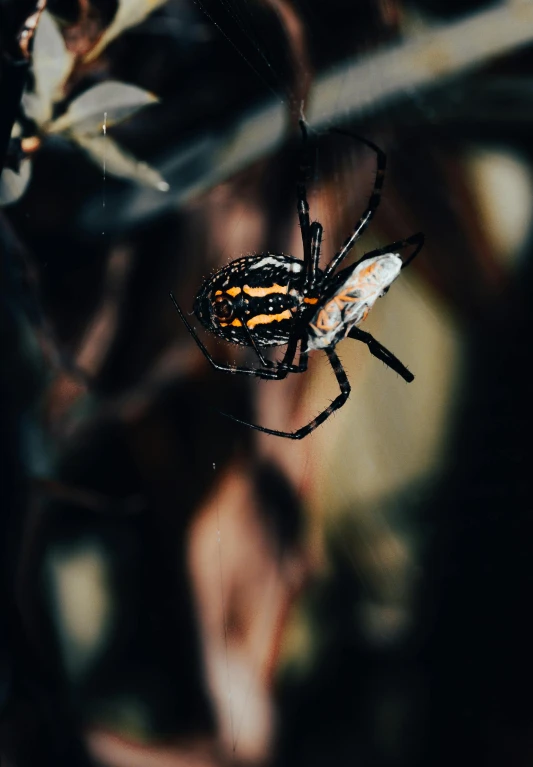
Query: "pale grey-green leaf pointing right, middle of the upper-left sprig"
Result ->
[[48, 80, 158, 134]]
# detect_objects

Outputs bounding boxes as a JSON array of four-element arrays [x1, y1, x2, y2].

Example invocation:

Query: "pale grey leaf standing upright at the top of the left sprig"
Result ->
[[22, 11, 74, 125]]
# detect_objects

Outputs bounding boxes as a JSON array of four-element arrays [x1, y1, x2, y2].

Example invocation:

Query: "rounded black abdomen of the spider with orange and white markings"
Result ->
[[194, 253, 322, 346]]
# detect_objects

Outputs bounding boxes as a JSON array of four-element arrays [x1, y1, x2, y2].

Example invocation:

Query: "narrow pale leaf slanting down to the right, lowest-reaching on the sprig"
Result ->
[[71, 133, 169, 192]]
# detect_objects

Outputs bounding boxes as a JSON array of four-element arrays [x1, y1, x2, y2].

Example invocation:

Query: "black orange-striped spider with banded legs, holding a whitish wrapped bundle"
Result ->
[[170, 119, 424, 439]]
